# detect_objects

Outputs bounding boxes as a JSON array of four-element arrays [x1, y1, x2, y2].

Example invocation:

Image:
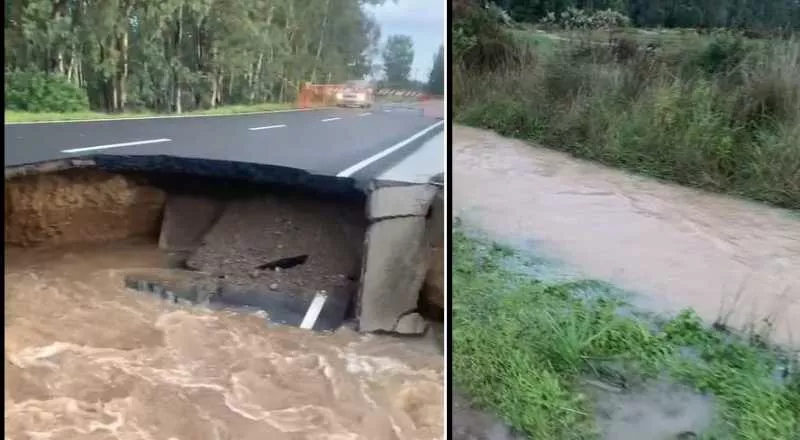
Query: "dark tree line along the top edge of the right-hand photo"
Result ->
[[495, 0, 800, 31]]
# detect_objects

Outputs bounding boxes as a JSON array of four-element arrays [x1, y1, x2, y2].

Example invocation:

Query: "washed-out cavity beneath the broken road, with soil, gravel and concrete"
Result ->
[[5, 167, 444, 334]]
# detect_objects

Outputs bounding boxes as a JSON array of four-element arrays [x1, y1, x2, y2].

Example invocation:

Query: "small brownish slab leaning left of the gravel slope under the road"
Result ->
[[158, 194, 225, 251]]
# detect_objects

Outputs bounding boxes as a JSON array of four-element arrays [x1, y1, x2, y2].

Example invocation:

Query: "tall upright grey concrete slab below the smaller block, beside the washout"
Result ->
[[358, 217, 430, 332]]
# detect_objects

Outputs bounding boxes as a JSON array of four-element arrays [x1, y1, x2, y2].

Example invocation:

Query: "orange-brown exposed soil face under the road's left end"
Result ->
[[5, 169, 165, 246]]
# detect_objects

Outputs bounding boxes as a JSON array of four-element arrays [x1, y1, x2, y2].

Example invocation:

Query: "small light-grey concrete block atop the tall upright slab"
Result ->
[[367, 185, 438, 221]]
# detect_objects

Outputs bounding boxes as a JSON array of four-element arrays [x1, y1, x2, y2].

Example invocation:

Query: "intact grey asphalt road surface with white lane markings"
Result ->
[[5, 106, 444, 177]]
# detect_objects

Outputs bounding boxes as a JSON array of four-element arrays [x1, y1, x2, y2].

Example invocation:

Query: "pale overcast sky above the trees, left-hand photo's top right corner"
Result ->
[[365, 0, 445, 81]]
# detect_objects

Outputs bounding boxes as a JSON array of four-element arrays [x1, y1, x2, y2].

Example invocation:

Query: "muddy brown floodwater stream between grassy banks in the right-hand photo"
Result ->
[[450, 126, 800, 345]]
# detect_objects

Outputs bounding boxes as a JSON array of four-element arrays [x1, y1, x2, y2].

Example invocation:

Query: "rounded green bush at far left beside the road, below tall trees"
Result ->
[[5, 71, 89, 113]]
